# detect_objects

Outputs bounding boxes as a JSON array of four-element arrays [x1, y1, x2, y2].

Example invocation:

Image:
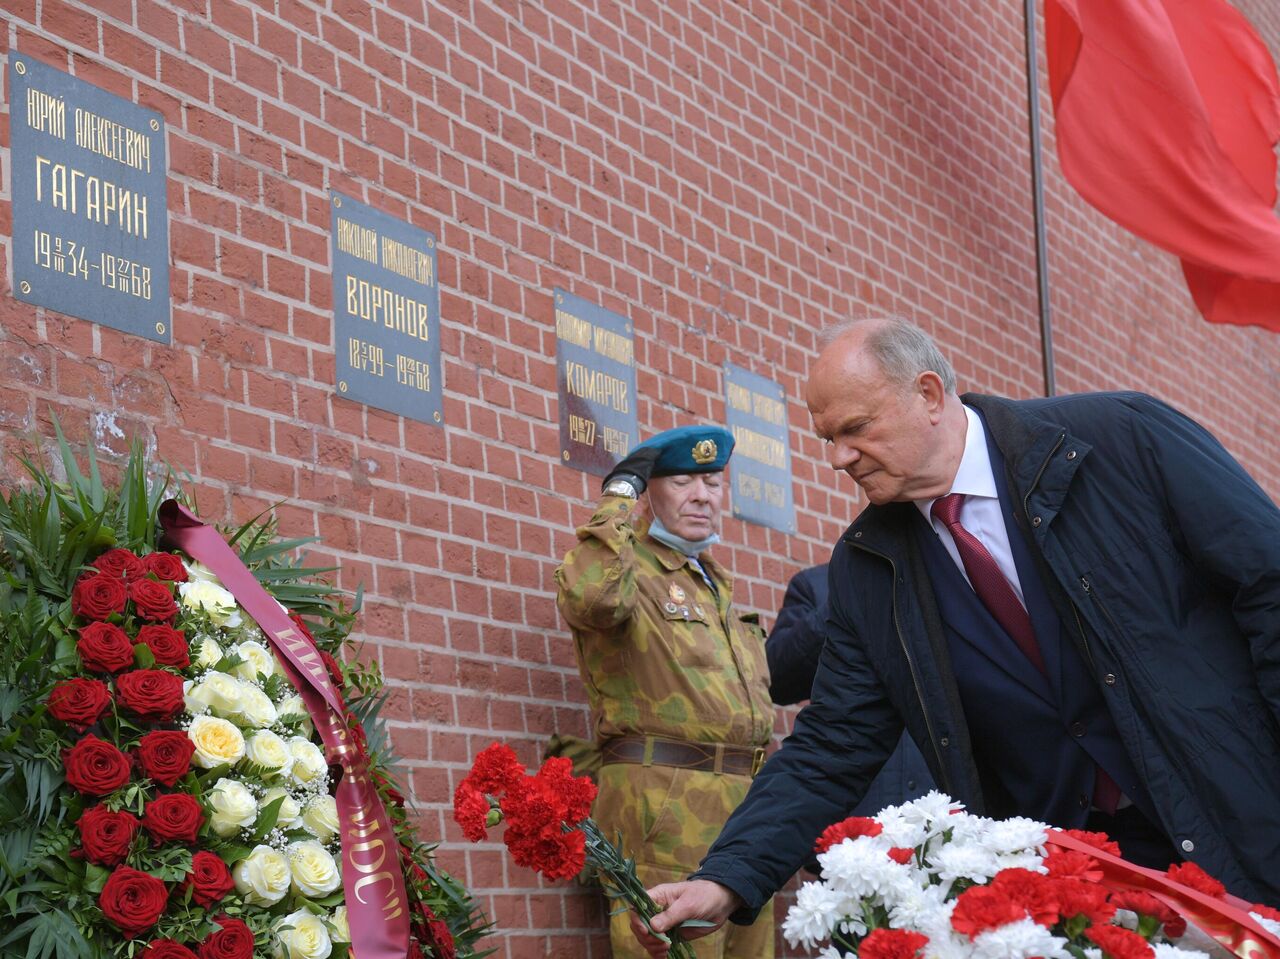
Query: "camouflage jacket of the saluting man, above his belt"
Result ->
[[556, 496, 773, 745]]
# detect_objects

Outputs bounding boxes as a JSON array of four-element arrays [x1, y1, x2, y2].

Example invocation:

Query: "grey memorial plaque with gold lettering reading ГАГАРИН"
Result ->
[[9, 54, 172, 343]]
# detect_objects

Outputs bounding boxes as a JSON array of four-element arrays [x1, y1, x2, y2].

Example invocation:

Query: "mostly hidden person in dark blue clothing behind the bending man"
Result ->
[[764, 563, 933, 824]]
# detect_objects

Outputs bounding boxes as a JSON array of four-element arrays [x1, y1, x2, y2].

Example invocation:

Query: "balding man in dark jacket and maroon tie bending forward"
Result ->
[[637, 320, 1280, 955]]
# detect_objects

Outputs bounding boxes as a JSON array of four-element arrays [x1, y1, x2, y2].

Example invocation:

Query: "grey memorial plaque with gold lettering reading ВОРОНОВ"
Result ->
[[330, 191, 444, 424]]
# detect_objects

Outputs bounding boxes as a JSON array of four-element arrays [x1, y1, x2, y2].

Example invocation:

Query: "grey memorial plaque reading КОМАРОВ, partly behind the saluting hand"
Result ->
[[556, 289, 640, 476]]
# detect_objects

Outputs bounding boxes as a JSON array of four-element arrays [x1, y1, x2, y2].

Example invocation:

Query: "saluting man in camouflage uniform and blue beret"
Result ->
[[556, 426, 773, 959]]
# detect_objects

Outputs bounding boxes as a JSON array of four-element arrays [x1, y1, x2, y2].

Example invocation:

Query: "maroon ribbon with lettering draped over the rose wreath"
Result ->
[[160, 499, 410, 959]]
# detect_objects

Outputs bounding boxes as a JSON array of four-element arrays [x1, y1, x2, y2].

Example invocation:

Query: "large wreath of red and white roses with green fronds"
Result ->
[[0, 440, 484, 959]]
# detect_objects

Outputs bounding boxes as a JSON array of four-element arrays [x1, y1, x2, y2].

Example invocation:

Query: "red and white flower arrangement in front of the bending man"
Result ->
[[782, 793, 1280, 959]]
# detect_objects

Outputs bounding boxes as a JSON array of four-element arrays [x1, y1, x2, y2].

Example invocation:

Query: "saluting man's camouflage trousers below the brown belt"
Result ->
[[591, 763, 773, 959]]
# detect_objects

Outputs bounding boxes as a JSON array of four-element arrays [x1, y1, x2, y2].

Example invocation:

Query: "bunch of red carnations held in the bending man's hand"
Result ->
[[453, 743, 705, 959]]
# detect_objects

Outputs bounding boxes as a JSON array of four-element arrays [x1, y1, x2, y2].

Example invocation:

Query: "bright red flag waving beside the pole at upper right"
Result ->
[[1044, 0, 1280, 332]]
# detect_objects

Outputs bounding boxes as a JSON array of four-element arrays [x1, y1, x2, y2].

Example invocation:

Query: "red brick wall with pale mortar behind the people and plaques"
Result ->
[[0, 0, 1280, 959]]
